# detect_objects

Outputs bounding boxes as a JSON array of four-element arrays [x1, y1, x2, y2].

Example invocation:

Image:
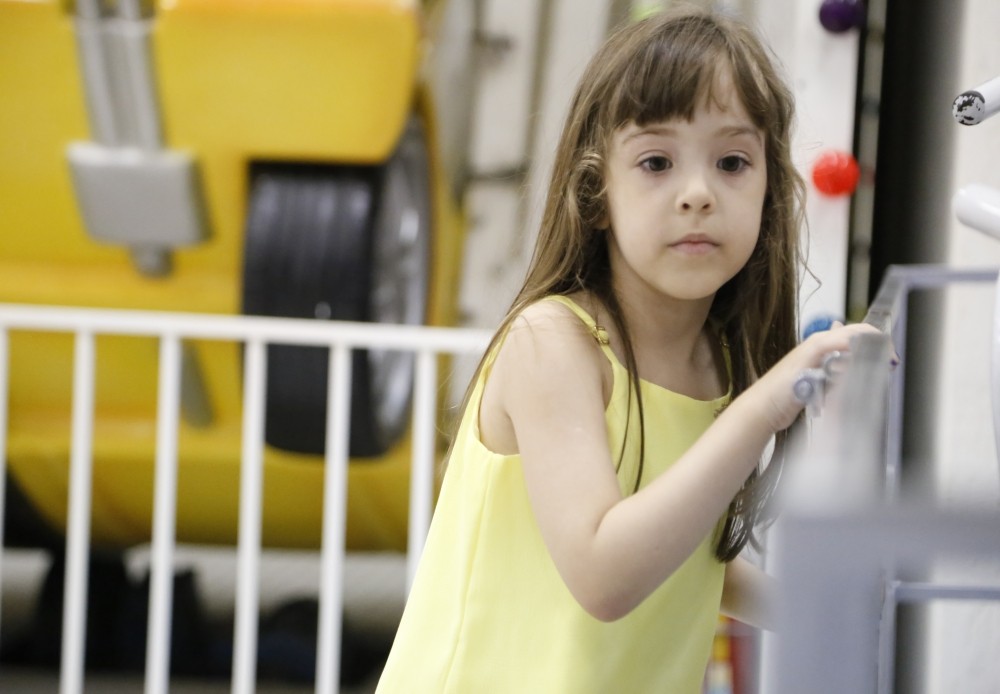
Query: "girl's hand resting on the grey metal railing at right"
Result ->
[[744, 323, 878, 432]]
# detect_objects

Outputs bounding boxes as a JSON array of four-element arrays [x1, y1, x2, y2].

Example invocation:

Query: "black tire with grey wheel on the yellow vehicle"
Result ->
[[243, 125, 430, 458]]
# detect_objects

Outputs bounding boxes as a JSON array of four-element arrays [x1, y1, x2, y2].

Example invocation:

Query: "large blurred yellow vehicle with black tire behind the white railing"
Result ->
[[0, 0, 462, 549]]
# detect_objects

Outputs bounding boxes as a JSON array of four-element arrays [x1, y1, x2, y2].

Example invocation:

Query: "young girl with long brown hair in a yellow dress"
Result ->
[[378, 6, 867, 694]]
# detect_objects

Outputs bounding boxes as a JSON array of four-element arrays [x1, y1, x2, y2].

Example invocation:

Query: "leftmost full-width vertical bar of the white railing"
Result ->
[[59, 331, 95, 694]]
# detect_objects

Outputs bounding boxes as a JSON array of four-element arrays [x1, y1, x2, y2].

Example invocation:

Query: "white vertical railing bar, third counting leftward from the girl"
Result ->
[[232, 339, 267, 694]]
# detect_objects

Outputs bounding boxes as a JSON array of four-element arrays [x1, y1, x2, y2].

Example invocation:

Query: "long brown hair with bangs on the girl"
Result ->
[[467, 10, 804, 561]]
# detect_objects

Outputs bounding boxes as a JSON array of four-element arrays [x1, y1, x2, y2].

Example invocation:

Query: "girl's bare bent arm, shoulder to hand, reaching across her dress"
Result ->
[[490, 302, 873, 620]]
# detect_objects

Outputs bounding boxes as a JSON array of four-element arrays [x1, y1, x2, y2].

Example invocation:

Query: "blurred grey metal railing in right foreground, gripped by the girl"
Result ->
[[768, 265, 1000, 694]]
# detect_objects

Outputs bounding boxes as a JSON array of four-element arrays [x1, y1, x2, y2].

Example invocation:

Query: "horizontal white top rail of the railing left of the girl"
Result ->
[[0, 304, 492, 354]]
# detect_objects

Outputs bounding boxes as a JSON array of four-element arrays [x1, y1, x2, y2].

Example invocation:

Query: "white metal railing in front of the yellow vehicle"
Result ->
[[0, 304, 490, 694]]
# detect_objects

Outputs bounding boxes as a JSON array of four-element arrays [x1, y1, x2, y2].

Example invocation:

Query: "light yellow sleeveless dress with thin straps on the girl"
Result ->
[[376, 297, 729, 694]]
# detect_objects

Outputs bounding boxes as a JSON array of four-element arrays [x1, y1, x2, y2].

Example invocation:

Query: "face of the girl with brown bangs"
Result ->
[[606, 74, 767, 310]]
